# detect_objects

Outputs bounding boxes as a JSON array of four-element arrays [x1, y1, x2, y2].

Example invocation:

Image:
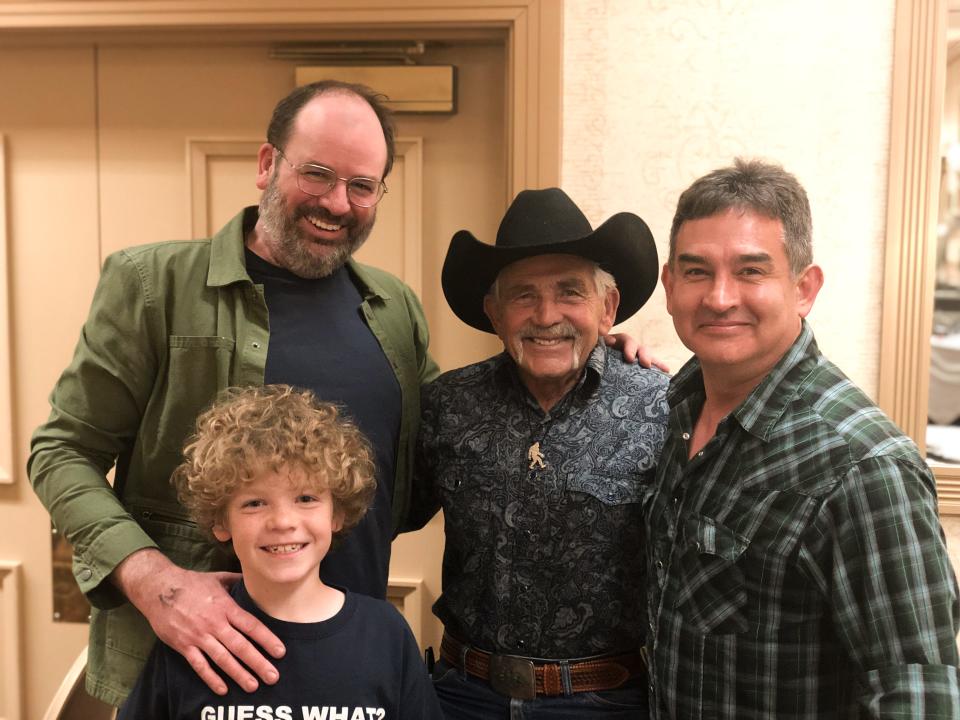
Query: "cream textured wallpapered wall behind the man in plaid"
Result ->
[[563, 0, 894, 395]]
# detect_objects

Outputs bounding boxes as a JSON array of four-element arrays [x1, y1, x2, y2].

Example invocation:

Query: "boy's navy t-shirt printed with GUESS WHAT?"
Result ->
[[117, 582, 443, 720]]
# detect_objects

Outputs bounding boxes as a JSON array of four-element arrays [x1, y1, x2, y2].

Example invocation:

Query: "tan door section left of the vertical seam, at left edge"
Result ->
[[0, 46, 100, 720]]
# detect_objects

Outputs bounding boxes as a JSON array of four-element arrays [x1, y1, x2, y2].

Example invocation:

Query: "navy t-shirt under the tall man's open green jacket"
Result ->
[[246, 250, 401, 598]]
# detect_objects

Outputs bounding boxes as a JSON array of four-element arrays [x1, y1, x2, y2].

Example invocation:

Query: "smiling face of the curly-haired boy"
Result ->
[[213, 468, 343, 593]]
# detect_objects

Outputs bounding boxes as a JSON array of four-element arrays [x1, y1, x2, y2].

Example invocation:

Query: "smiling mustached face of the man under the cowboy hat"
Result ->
[[484, 255, 620, 394]]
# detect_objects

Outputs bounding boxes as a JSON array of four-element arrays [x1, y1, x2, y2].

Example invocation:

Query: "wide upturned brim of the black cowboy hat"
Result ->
[[440, 212, 660, 333]]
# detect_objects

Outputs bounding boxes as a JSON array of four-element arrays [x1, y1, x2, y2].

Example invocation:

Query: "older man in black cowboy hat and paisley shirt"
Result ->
[[404, 188, 667, 718]]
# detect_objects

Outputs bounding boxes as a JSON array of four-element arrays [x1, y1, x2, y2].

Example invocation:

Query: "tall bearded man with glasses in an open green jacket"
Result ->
[[28, 81, 437, 705]]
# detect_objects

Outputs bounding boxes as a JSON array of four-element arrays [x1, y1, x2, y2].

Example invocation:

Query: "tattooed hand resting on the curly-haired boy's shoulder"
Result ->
[[113, 550, 286, 695]]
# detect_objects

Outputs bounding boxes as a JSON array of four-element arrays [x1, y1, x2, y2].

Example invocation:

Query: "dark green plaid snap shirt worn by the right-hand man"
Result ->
[[647, 323, 960, 720]]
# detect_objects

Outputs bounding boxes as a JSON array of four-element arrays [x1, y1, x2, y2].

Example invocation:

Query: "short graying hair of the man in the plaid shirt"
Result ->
[[669, 158, 813, 276]]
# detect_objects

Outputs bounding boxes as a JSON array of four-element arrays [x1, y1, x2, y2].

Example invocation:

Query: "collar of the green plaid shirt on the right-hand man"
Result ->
[[667, 320, 820, 440]]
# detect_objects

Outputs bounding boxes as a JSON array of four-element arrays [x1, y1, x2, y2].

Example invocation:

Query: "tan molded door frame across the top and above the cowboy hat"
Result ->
[[0, 0, 563, 195]]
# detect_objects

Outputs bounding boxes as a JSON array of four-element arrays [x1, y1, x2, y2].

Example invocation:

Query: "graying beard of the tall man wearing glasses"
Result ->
[[260, 173, 376, 280]]
